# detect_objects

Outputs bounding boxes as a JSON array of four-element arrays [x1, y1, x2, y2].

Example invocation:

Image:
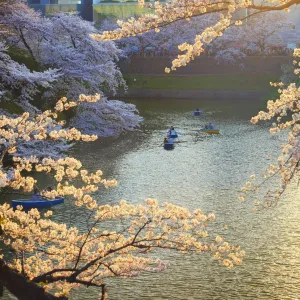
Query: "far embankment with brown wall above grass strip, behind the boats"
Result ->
[[117, 56, 292, 100]]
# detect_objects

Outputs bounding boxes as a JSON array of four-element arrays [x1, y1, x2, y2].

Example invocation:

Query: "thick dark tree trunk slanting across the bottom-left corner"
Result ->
[[0, 259, 68, 300]]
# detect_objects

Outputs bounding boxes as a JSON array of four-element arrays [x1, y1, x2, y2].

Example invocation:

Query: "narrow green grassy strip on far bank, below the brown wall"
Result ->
[[124, 74, 278, 91]]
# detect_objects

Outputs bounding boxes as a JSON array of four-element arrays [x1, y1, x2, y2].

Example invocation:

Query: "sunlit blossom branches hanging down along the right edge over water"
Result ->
[[240, 49, 300, 207]]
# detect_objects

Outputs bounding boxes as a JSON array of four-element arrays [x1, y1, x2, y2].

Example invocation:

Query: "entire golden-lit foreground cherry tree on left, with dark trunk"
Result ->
[[0, 95, 244, 300]]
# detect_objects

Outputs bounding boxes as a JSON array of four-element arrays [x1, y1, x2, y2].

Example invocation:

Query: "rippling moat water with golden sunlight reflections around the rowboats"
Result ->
[[5, 100, 300, 300]]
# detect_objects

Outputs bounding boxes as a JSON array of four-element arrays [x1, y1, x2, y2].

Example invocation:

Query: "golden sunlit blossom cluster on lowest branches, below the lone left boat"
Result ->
[[0, 199, 244, 295]]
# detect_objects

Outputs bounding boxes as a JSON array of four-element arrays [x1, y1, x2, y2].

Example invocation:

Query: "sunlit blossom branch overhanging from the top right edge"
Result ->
[[94, 0, 299, 72]]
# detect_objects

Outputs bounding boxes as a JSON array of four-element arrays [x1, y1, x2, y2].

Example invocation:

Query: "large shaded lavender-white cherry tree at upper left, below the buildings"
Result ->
[[1, 4, 124, 98]]
